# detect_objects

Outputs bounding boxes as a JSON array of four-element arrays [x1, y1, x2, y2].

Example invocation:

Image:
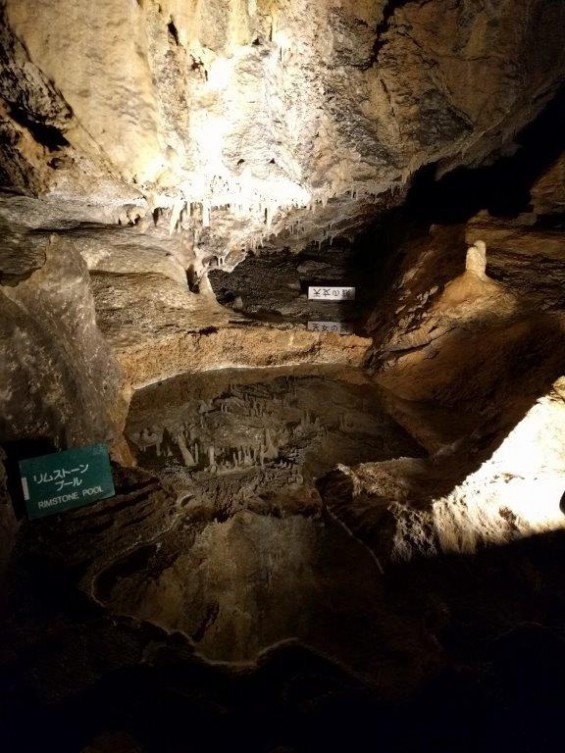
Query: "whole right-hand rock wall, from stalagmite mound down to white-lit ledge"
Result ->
[[352, 166, 565, 562]]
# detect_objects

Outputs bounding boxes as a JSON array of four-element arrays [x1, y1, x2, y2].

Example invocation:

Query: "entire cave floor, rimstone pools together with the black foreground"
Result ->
[[0, 366, 565, 753]]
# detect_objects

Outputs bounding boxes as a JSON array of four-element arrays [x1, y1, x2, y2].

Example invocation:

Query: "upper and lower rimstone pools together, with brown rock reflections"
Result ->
[[117, 367, 421, 675]]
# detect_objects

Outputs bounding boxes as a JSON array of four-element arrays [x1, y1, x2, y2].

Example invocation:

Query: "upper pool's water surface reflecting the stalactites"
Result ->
[[126, 367, 420, 507]]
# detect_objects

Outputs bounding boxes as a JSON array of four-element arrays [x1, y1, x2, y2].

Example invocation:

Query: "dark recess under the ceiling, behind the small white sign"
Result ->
[[209, 81, 565, 334]]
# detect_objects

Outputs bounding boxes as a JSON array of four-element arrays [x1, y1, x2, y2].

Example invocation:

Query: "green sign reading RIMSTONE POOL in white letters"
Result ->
[[20, 444, 115, 519]]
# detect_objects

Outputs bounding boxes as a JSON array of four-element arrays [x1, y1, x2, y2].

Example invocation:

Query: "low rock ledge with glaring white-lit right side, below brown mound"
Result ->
[[321, 379, 565, 563]]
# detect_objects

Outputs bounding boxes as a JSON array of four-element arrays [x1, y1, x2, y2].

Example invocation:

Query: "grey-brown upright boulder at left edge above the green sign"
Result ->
[[0, 229, 127, 448]]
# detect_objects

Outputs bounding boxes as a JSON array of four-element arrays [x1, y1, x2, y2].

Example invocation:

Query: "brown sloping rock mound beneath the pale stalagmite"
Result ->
[[369, 222, 563, 412]]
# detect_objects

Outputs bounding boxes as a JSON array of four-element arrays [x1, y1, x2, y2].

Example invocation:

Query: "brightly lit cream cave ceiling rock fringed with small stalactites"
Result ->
[[0, 0, 565, 263]]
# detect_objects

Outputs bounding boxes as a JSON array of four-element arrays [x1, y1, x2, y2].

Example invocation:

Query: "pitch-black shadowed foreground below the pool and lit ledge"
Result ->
[[0, 531, 565, 753]]
